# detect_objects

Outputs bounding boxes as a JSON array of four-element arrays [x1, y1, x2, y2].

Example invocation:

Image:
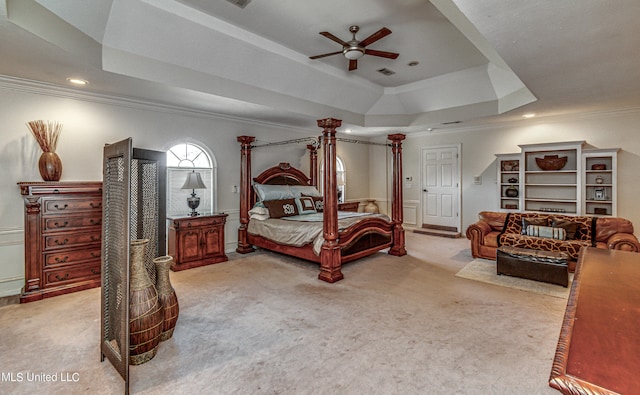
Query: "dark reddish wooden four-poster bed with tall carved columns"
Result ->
[[236, 118, 406, 283]]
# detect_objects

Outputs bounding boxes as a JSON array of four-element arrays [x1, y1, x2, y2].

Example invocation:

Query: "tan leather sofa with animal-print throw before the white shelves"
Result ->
[[467, 211, 640, 260]]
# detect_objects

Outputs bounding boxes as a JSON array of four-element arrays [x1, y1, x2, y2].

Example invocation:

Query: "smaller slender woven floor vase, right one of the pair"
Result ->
[[153, 255, 180, 341]]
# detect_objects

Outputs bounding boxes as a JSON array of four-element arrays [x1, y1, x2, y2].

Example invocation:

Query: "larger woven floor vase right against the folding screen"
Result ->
[[129, 239, 163, 365]]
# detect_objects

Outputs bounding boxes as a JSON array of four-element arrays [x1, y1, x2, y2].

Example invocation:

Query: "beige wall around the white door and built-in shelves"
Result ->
[[392, 110, 640, 234]]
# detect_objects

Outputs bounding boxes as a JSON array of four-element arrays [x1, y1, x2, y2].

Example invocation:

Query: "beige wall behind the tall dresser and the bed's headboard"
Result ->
[[0, 82, 369, 297]]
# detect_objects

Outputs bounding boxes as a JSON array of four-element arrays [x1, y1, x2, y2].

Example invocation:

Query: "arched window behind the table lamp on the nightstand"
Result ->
[[167, 143, 217, 216]]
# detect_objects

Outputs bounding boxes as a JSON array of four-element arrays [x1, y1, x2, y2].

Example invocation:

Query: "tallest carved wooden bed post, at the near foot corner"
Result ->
[[318, 118, 344, 283]]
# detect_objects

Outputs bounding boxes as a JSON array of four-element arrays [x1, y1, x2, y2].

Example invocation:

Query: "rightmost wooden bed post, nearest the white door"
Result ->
[[388, 133, 407, 256]]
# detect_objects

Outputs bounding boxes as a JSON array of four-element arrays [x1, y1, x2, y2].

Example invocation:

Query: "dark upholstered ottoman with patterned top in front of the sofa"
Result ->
[[496, 246, 569, 287]]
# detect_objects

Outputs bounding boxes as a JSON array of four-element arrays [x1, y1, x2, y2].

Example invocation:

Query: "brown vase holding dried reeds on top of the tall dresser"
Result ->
[[27, 120, 62, 181]]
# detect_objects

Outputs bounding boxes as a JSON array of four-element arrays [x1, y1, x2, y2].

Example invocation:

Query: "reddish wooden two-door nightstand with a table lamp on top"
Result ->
[[167, 214, 228, 271]]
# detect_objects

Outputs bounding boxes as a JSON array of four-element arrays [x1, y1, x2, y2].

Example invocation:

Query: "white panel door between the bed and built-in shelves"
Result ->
[[422, 147, 460, 229]]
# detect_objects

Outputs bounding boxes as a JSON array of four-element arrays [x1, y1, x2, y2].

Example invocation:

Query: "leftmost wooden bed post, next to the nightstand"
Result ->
[[236, 136, 256, 254]]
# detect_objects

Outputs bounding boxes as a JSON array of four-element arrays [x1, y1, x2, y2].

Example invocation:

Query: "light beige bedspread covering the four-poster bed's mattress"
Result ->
[[247, 212, 390, 255]]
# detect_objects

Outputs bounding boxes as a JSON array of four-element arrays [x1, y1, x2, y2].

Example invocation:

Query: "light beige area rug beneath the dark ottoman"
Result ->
[[456, 259, 573, 299]]
